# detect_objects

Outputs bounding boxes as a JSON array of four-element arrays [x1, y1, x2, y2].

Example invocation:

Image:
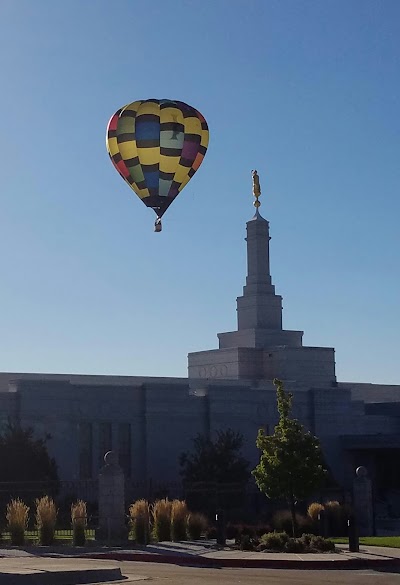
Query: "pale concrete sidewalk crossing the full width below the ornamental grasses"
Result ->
[[0, 541, 400, 571]]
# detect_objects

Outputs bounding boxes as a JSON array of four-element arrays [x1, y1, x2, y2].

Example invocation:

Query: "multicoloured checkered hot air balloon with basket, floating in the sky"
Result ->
[[106, 99, 208, 232]]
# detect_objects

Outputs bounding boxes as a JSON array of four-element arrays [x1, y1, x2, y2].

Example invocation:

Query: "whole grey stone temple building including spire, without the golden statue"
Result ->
[[0, 203, 400, 500]]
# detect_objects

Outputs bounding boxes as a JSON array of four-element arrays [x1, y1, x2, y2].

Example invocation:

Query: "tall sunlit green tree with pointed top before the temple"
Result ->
[[252, 379, 327, 535]]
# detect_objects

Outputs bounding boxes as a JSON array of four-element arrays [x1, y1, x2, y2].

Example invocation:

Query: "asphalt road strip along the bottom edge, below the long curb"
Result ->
[[119, 561, 400, 585]]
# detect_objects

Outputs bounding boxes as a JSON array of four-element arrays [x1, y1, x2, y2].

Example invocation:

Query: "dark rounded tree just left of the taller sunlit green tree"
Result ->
[[179, 429, 250, 512]]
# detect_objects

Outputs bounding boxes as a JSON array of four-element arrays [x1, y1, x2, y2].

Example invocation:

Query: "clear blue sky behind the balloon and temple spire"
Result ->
[[0, 0, 400, 383]]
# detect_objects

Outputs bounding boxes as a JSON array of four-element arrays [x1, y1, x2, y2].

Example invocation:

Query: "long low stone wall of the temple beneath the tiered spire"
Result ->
[[0, 370, 399, 492]]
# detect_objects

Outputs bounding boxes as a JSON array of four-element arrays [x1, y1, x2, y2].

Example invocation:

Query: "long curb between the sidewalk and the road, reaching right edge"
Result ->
[[84, 553, 400, 571]]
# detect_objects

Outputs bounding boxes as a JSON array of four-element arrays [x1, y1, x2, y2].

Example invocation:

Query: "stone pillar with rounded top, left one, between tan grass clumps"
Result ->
[[96, 451, 128, 544]]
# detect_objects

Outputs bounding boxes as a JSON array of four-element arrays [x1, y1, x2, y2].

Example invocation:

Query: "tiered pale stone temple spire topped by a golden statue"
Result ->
[[189, 170, 306, 380]]
